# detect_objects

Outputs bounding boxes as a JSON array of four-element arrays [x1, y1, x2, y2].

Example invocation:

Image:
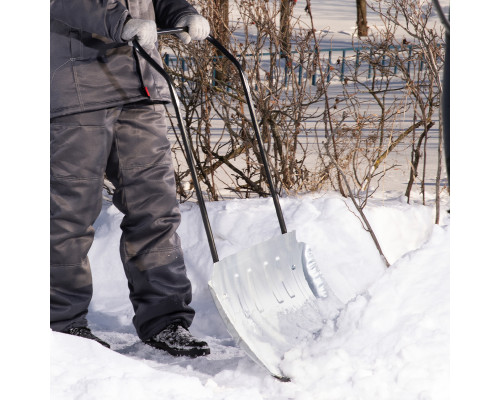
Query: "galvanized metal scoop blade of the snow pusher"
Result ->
[[209, 232, 328, 380]]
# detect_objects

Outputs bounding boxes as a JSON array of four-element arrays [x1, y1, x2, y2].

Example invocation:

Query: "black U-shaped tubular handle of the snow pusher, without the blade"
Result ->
[[132, 27, 287, 263]]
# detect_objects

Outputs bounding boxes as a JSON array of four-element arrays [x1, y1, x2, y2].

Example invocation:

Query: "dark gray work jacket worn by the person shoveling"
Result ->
[[50, 0, 197, 118]]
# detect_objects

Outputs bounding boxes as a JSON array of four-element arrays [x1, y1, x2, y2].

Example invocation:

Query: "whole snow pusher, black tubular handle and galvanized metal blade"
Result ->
[[133, 28, 335, 381]]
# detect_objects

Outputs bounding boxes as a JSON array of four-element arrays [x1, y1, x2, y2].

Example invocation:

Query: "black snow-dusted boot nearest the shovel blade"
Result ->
[[144, 323, 210, 358]]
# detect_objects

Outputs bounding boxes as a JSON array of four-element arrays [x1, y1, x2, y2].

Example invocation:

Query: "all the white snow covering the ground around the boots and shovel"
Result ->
[[51, 193, 449, 400]]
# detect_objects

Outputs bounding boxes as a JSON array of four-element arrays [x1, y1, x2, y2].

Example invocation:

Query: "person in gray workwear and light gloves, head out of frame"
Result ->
[[50, 0, 210, 357]]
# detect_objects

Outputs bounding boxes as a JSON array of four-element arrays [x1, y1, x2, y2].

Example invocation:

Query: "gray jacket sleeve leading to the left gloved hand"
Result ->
[[50, 0, 128, 42]]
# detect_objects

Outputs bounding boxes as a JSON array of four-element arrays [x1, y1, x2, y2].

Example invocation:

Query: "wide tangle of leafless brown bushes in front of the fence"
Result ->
[[123, 0, 443, 208]]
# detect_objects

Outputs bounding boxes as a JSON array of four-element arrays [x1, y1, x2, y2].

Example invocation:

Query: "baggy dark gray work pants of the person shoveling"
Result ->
[[50, 103, 194, 340]]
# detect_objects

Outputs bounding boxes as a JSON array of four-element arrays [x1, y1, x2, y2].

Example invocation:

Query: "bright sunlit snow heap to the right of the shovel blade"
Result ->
[[283, 223, 449, 399]]
